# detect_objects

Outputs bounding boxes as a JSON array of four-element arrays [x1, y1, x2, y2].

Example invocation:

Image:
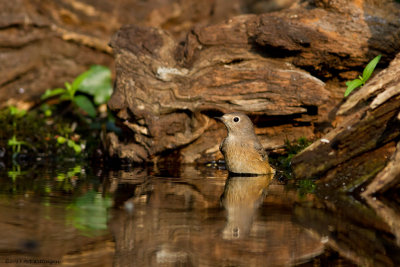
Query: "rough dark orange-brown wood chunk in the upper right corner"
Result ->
[[252, 0, 400, 79]]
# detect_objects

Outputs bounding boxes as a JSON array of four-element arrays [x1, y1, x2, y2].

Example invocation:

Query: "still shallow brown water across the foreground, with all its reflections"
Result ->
[[0, 164, 400, 266]]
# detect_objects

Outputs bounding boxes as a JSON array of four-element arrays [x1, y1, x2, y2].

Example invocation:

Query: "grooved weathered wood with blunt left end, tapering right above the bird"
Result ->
[[109, 21, 329, 162]]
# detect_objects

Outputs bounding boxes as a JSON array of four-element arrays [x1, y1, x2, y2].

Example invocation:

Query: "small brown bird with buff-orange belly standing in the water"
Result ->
[[218, 112, 275, 177]]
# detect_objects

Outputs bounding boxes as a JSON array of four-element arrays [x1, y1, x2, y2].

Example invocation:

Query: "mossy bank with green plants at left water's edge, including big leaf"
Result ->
[[0, 65, 118, 165]]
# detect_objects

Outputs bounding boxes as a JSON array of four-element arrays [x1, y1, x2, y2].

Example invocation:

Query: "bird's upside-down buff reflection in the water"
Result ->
[[221, 174, 273, 239]]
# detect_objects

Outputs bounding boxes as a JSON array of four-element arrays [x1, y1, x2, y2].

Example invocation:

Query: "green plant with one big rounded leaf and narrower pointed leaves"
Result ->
[[41, 65, 112, 118]]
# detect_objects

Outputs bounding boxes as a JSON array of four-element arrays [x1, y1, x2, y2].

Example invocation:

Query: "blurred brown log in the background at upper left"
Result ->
[[0, 0, 248, 108]]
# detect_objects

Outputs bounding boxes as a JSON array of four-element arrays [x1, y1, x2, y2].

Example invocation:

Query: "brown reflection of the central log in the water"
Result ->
[[109, 174, 323, 266]]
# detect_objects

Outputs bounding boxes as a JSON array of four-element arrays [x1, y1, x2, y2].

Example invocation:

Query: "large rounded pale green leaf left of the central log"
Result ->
[[79, 65, 113, 105]]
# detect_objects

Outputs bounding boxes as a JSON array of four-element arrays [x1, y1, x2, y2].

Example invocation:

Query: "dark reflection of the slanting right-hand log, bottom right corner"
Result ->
[[294, 194, 400, 267]]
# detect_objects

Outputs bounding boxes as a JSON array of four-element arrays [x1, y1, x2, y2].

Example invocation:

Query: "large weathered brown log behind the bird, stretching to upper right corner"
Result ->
[[105, 0, 400, 162]]
